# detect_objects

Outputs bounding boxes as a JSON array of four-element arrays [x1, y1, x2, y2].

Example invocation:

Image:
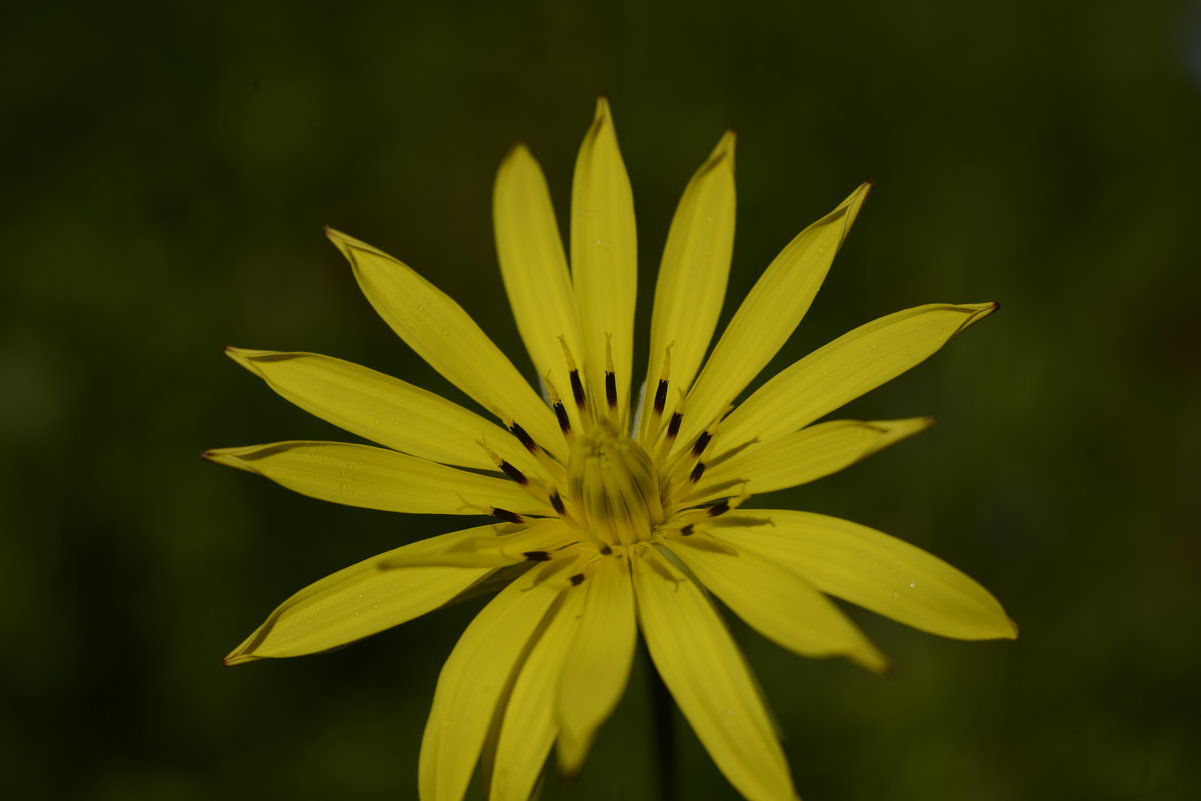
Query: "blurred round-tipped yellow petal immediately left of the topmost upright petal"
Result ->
[[492, 144, 584, 432]]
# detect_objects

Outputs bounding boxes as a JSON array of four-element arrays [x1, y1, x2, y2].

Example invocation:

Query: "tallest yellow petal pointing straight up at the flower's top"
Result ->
[[572, 97, 638, 411]]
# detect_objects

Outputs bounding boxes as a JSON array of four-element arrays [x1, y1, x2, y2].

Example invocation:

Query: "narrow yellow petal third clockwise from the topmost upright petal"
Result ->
[[717, 303, 998, 448]]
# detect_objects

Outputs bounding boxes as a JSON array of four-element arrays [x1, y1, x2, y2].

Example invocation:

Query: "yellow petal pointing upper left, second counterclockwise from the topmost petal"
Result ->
[[327, 228, 566, 455]]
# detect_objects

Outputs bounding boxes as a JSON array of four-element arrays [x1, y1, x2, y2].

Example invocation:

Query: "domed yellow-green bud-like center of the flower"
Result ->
[[567, 419, 663, 545]]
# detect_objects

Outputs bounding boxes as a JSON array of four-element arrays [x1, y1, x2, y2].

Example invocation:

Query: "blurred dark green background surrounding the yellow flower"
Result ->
[[0, 0, 1201, 801]]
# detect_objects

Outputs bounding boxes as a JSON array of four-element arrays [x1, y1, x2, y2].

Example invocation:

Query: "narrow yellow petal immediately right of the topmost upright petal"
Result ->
[[646, 131, 735, 408]]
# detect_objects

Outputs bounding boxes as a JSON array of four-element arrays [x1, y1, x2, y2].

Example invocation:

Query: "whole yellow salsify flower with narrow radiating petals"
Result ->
[[205, 98, 1016, 801]]
